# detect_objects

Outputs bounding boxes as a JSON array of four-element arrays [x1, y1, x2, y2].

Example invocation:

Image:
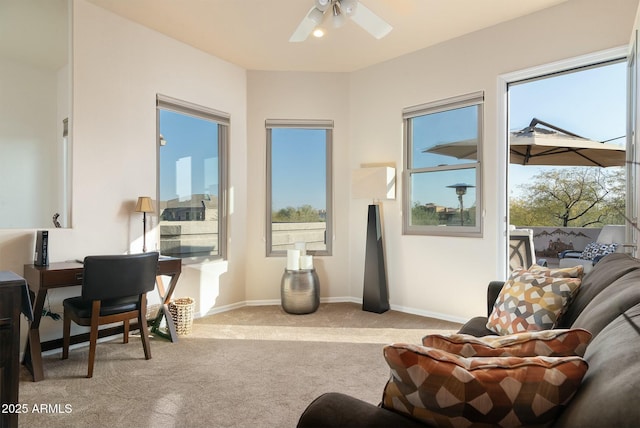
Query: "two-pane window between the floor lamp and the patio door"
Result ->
[[402, 92, 484, 236]]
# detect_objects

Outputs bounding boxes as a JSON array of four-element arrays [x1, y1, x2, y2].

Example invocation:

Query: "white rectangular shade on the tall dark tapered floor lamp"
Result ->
[[351, 166, 396, 200]]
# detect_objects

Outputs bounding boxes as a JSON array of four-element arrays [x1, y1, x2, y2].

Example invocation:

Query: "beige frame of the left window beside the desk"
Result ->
[[156, 94, 231, 262]]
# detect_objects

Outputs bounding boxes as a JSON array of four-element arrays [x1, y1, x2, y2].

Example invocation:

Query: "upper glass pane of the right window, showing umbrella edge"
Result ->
[[411, 105, 479, 168]]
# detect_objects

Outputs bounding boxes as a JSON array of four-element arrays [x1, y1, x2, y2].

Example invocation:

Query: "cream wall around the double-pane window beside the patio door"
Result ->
[[345, 0, 638, 319]]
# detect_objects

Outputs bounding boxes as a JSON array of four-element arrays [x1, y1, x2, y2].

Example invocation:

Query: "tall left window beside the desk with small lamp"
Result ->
[[156, 95, 229, 258]]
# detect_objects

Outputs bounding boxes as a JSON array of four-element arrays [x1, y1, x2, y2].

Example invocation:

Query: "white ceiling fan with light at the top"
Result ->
[[289, 0, 393, 42]]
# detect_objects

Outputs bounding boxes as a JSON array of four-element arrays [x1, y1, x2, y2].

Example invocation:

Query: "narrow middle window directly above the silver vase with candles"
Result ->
[[266, 120, 333, 256]]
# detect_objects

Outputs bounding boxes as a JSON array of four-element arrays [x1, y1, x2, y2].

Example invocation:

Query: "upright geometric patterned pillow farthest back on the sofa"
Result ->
[[487, 271, 581, 335]]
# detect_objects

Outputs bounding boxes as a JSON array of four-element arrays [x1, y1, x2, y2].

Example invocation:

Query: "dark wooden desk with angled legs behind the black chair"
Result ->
[[23, 257, 182, 382]]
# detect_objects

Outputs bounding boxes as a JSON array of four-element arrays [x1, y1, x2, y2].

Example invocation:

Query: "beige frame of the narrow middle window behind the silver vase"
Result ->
[[265, 119, 333, 257]]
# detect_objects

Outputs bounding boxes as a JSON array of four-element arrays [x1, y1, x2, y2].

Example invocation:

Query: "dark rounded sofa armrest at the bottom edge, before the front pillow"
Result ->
[[297, 392, 425, 428]]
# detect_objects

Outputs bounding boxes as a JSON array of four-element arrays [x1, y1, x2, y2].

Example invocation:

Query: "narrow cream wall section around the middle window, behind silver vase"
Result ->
[[247, 71, 352, 303]]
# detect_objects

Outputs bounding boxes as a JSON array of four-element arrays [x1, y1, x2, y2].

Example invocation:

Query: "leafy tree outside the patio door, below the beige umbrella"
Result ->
[[509, 167, 625, 227]]
